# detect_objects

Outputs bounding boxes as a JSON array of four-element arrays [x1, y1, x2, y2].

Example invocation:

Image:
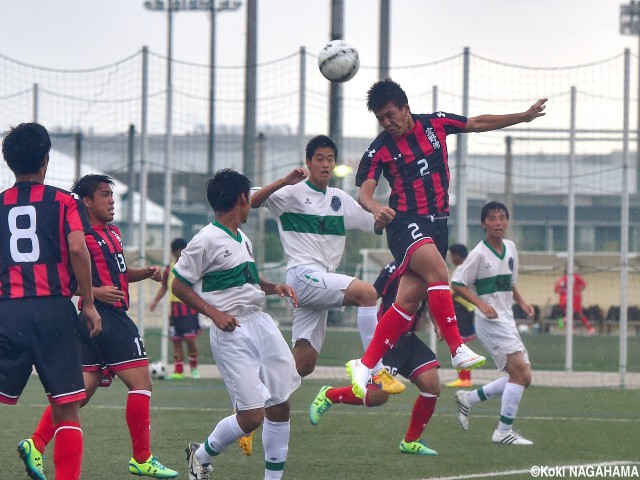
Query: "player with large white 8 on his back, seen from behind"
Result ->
[[0, 123, 102, 480]]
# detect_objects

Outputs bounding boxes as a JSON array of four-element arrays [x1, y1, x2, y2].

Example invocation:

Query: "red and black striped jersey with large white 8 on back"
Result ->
[[0, 182, 89, 300]]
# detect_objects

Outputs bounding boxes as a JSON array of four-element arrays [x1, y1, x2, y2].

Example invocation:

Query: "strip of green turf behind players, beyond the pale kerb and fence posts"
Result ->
[[145, 328, 640, 372]]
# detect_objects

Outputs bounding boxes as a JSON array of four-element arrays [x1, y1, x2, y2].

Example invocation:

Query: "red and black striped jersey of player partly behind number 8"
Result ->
[[85, 224, 129, 310]]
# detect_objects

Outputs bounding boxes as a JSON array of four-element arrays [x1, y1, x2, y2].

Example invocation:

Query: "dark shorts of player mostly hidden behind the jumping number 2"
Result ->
[[382, 333, 440, 381]]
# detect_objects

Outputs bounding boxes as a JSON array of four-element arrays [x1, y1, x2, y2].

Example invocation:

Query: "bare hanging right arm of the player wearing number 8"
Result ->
[[67, 230, 102, 337]]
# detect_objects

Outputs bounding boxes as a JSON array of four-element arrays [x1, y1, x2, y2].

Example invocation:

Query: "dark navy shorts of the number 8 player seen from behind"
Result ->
[[0, 296, 86, 405]]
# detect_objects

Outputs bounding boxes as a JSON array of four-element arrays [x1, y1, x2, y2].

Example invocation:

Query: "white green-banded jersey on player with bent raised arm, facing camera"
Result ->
[[262, 181, 375, 272]]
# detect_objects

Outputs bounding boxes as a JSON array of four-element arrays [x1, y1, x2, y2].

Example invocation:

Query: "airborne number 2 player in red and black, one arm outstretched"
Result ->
[[347, 78, 547, 396]]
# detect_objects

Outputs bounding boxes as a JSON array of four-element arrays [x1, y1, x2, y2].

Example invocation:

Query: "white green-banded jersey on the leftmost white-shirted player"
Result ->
[[173, 221, 265, 316]]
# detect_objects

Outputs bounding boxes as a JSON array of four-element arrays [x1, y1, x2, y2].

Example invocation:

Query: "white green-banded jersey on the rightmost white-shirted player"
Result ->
[[451, 240, 518, 323]]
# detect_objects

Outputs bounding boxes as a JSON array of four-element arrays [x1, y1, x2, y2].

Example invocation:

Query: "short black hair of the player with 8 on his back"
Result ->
[[2, 123, 51, 175]]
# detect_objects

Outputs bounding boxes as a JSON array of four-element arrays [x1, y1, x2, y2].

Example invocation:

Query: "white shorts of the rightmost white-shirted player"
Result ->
[[476, 315, 531, 371]]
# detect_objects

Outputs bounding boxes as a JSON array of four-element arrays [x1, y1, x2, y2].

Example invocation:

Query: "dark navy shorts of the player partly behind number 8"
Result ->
[[82, 302, 149, 373]]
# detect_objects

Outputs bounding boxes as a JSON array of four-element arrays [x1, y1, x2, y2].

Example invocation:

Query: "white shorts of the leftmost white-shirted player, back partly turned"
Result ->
[[209, 311, 300, 411]]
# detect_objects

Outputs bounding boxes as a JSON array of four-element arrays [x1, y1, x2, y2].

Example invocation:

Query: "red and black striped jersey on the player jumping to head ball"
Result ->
[[356, 112, 467, 215]]
